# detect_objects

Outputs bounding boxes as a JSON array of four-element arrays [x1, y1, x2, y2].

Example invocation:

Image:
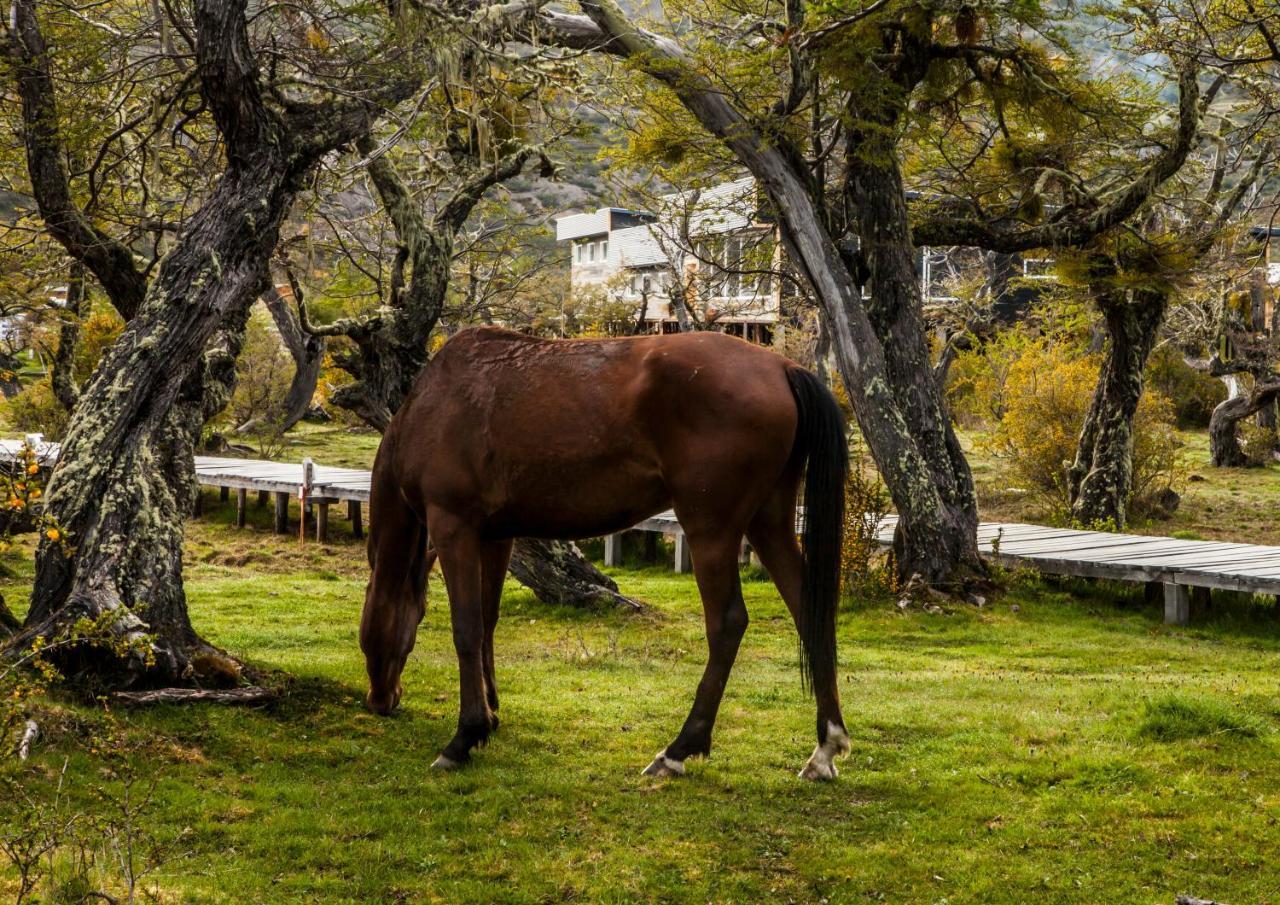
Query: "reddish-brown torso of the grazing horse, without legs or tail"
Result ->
[[388, 328, 795, 536]]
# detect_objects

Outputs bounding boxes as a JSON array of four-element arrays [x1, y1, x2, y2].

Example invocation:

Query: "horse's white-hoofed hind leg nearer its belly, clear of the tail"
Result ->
[[644, 534, 748, 776]]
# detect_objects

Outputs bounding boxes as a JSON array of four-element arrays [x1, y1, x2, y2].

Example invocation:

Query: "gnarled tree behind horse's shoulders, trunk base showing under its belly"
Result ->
[[288, 83, 636, 608]]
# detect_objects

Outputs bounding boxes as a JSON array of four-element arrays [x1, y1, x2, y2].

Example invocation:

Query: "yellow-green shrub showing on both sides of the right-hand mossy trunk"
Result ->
[[988, 343, 1181, 516]]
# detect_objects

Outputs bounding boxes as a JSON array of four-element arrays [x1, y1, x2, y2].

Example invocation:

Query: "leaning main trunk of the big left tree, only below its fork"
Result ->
[[23, 147, 298, 684]]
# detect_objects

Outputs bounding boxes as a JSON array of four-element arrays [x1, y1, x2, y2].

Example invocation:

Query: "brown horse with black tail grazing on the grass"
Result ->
[[360, 328, 849, 780]]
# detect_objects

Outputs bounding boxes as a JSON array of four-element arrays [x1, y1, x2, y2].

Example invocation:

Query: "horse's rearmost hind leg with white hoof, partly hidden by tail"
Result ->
[[746, 486, 849, 780]]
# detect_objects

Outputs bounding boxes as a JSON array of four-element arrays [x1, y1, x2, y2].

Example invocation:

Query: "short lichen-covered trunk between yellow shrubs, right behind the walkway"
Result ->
[[1068, 289, 1167, 530]]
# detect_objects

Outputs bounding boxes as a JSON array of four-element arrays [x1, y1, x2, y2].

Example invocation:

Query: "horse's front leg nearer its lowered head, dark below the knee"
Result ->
[[428, 512, 494, 769]]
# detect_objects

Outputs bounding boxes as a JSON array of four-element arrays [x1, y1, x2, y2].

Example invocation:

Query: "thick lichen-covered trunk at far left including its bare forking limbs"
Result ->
[[12, 0, 419, 685]]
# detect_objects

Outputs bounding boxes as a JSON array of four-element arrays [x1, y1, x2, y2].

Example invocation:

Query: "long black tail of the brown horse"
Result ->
[[787, 367, 849, 690]]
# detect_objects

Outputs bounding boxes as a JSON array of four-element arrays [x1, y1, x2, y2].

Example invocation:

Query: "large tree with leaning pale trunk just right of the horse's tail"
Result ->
[[529, 0, 1213, 584]]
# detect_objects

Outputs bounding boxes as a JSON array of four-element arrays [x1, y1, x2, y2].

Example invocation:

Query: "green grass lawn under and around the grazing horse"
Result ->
[[6, 504, 1280, 904]]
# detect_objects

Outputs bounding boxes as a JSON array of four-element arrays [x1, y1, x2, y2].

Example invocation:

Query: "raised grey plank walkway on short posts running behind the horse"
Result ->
[[0, 436, 1280, 625]]
